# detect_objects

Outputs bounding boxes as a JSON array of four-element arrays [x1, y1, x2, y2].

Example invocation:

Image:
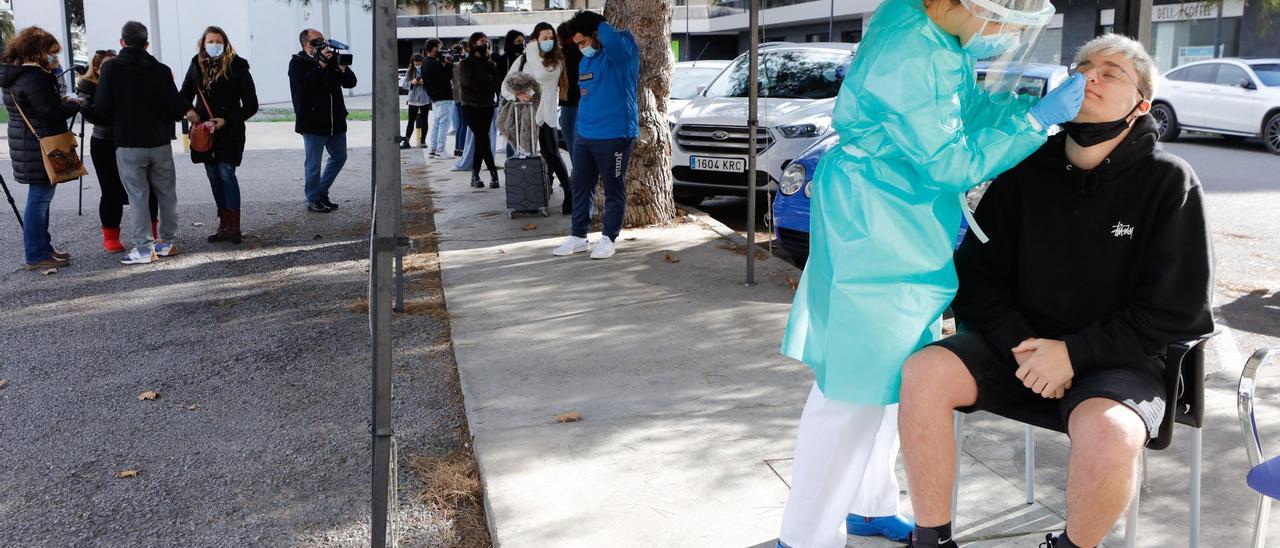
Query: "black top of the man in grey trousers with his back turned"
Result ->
[[93, 47, 191, 149]]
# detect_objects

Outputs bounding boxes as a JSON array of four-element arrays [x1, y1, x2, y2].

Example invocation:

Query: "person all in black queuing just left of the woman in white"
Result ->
[[458, 32, 507, 188]]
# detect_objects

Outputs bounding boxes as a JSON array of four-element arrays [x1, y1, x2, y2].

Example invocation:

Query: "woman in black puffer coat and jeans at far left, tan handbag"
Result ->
[[0, 27, 79, 270]]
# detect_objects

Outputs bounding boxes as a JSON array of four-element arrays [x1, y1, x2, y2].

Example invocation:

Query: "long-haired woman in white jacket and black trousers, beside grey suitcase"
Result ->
[[499, 23, 573, 215]]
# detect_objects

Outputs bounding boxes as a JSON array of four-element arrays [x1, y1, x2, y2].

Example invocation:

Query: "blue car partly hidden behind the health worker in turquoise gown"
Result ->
[[773, 63, 1068, 268]]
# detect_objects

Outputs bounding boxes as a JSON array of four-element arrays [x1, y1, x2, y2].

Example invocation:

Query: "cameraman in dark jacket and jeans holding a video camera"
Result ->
[[289, 28, 356, 213]]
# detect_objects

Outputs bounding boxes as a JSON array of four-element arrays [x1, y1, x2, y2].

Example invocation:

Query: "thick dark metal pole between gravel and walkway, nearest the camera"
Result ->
[[369, 0, 401, 548]]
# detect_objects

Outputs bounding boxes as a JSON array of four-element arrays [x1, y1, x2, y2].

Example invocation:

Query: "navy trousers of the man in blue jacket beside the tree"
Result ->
[[570, 137, 636, 242]]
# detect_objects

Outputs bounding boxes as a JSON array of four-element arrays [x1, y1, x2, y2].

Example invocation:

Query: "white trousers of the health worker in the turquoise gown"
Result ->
[[780, 384, 899, 548]]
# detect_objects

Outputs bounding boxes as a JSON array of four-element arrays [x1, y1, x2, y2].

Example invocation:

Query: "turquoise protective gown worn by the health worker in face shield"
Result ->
[[782, 0, 1046, 405]]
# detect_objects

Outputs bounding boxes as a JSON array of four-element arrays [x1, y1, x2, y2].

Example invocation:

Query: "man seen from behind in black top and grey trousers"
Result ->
[[93, 20, 200, 265]]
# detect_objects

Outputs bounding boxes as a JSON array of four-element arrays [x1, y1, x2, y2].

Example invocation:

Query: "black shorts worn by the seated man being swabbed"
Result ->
[[931, 332, 1165, 438]]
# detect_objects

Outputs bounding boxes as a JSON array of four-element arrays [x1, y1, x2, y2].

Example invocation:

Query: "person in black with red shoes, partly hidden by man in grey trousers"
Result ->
[[76, 50, 160, 254]]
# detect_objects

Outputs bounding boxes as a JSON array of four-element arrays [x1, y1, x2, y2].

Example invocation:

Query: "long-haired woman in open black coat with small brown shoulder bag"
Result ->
[[179, 27, 257, 243]]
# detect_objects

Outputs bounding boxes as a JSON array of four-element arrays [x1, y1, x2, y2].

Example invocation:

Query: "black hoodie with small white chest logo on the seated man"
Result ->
[[952, 112, 1213, 374]]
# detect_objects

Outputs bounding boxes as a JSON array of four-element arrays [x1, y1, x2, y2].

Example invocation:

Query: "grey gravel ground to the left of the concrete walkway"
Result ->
[[0, 135, 465, 547]]
